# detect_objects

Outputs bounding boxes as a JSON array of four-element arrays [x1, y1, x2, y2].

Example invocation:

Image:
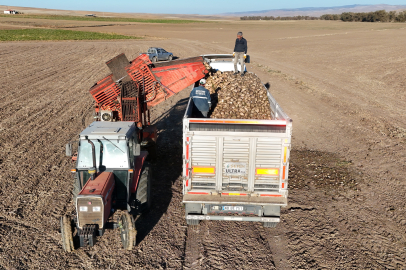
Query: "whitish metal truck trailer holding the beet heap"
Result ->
[[183, 55, 292, 227]]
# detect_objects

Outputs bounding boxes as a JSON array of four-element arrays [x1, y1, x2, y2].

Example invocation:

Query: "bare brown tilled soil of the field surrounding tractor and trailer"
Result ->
[[0, 22, 406, 269]]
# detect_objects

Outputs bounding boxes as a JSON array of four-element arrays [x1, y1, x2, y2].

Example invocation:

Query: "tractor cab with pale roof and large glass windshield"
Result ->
[[76, 121, 141, 208]]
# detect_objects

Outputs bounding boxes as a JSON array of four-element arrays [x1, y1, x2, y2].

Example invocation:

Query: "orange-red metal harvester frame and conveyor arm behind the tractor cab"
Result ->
[[90, 54, 208, 125]]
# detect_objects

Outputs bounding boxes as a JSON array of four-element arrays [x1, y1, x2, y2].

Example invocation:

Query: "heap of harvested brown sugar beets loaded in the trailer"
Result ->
[[206, 66, 271, 120]]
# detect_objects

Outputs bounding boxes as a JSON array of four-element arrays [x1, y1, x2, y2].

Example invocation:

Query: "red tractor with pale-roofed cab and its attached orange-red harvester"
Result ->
[[60, 54, 207, 252]]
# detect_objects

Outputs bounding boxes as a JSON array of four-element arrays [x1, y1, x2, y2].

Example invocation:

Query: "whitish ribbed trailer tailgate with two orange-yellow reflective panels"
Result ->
[[183, 107, 291, 205]]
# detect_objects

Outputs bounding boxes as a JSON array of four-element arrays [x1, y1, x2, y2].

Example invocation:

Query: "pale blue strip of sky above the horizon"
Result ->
[[0, 0, 406, 14]]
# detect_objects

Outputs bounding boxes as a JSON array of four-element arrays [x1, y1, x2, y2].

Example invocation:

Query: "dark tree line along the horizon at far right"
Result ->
[[240, 10, 406, 22]]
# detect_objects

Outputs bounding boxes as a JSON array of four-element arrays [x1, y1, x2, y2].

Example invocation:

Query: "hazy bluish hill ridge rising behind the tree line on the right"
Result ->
[[221, 4, 406, 17]]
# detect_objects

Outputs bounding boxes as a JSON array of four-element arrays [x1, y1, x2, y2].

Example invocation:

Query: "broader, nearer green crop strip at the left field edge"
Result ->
[[0, 29, 139, 41]]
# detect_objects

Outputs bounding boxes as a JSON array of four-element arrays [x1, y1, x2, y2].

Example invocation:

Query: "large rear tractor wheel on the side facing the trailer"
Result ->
[[135, 162, 151, 212]]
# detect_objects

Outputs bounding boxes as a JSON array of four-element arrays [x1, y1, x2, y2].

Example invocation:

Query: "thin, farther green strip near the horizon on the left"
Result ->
[[0, 14, 202, 24]]
